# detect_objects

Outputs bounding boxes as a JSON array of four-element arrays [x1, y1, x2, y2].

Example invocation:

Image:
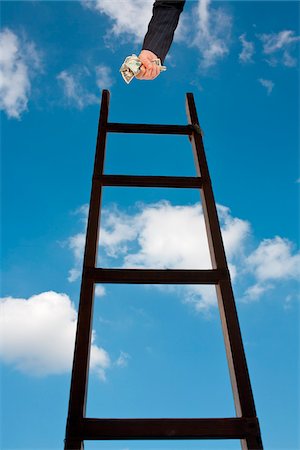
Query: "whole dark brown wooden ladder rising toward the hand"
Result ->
[[64, 90, 263, 450]]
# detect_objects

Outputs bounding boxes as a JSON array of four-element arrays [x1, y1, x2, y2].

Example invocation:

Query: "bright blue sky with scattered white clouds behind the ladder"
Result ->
[[0, 0, 300, 450]]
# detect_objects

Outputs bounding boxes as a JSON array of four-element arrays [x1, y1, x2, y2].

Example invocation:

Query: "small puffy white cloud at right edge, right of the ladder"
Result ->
[[247, 236, 300, 282]]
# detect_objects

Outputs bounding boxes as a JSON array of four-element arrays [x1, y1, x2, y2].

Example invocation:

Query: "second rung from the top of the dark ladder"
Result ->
[[96, 175, 202, 188]]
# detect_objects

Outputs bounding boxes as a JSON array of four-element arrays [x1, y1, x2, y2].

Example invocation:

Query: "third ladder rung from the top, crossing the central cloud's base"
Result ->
[[84, 268, 228, 284]]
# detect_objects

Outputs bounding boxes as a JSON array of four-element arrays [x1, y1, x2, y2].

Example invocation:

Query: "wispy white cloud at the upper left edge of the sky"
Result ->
[[0, 28, 41, 119]]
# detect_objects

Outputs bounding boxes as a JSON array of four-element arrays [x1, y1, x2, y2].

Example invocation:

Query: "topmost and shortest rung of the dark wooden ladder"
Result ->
[[106, 122, 194, 136]]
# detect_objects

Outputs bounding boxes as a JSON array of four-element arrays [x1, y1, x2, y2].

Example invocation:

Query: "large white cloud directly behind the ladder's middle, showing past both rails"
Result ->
[[69, 201, 250, 311]]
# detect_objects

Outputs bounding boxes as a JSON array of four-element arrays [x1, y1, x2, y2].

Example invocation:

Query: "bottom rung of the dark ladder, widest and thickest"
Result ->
[[80, 418, 258, 440]]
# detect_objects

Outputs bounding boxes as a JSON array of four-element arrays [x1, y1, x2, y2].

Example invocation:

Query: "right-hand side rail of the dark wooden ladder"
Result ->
[[186, 93, 260, 448]]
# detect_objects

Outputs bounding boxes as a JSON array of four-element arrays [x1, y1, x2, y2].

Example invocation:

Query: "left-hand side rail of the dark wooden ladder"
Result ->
[[65, 91, 109, 449]]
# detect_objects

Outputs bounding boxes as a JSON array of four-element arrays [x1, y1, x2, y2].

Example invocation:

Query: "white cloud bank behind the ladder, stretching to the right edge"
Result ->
[[69, 204, 300, 314]]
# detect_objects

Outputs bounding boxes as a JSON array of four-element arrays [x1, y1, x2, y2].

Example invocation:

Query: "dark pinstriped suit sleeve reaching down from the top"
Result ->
[[142, 0, 185, 62]]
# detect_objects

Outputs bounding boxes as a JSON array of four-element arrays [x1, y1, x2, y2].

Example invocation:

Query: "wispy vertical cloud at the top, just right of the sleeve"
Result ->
[[190, 0, 232, 69]]
